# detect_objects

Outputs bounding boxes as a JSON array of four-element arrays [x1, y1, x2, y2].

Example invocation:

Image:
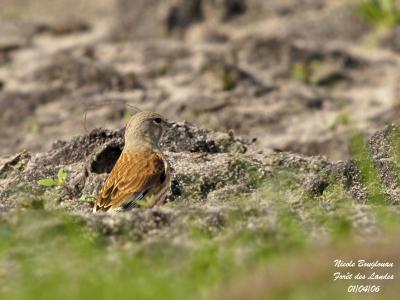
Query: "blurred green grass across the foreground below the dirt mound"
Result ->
[[0, 135, 400, 300]]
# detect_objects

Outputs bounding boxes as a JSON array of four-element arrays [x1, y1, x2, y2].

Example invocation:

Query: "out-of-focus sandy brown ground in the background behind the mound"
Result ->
[[0, 0, 400, 160]]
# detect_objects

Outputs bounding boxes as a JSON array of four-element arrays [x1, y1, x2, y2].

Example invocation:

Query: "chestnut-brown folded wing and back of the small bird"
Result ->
[[96, 150, 165, 210]]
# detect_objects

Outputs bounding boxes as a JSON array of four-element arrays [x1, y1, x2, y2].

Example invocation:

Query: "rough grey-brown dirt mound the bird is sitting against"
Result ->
[[0, 123, 400, 246]]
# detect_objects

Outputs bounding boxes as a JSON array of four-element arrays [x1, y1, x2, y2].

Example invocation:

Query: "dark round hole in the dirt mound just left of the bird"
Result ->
[[90, 144, 122, 174]]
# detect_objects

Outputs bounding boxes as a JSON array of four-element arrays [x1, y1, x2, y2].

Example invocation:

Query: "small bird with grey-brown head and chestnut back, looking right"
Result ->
[[93, 111, 171, 212]]
